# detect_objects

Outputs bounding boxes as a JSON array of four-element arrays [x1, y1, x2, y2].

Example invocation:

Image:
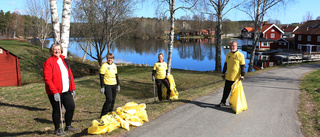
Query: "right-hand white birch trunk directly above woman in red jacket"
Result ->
[[61, 0, 72, 57]]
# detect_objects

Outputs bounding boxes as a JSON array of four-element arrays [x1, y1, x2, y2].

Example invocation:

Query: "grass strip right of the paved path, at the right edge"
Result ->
[[298, 70, 320, 137]]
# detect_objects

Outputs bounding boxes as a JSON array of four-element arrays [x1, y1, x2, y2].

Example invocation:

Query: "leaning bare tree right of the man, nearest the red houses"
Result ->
[[239, 0, 290, 72]]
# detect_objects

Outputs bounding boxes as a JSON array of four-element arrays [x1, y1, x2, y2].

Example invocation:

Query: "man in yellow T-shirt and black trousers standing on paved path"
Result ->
[[217, 41, 245, 107]]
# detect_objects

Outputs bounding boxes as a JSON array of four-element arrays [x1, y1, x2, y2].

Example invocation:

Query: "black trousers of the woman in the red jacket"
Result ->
[[48, 91, 75, 130]]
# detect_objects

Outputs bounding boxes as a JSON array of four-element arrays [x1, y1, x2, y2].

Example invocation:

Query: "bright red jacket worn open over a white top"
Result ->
[[42, 55, 76, 95]]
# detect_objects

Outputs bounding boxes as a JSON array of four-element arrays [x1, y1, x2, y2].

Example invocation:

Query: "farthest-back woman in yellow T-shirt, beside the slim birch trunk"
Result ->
[[152, 53, 171, 101]]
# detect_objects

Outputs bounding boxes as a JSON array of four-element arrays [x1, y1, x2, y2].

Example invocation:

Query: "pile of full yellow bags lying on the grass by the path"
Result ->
[[88, 102, 149, 134]]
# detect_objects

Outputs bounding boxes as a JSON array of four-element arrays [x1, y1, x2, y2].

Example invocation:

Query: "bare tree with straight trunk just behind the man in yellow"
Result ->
[[204, 0, 247, 72]]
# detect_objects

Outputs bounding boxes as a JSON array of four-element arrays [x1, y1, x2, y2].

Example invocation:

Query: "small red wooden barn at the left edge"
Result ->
[[0, 47, 21, 87]]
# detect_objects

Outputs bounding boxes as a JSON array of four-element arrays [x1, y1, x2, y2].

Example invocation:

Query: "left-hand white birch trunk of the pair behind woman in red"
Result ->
[[50, 0, 60, 43]]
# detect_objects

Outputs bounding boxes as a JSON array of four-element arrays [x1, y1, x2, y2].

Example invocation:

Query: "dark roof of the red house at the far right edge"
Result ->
[[294, 20, 320, 35]]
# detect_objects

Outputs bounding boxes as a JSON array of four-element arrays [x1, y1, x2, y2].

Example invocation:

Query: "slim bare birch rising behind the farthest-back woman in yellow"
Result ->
[[156, 0, 198, 73]]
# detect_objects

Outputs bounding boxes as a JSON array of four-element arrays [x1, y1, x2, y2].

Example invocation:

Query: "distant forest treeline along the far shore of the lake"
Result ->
[[0, 10, 253, 39]]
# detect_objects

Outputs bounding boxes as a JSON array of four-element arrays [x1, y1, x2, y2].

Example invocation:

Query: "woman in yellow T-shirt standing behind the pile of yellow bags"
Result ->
[[100, 53, 120, 117]]
